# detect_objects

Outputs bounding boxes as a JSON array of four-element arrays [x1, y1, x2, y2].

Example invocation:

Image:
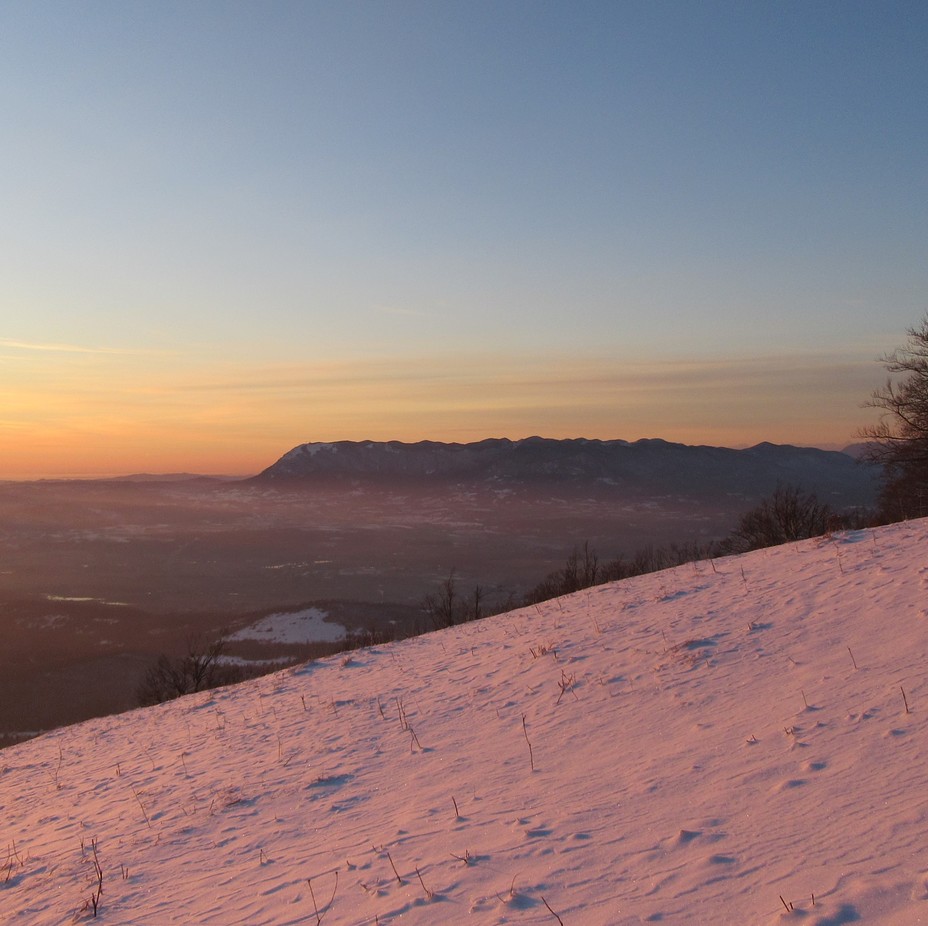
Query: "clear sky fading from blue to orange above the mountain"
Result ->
[[0, 0, 928, 479]]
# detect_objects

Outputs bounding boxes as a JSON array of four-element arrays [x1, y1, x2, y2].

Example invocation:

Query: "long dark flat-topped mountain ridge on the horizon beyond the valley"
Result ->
[[254, 437, 879, 505]]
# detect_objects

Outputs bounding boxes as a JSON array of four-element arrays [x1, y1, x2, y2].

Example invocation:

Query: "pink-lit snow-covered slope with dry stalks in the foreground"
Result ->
[[0, 521, 928, 926]]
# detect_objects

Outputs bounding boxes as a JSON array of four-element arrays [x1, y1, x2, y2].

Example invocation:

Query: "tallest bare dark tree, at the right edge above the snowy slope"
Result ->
[[860, 315, 928, 520]]
